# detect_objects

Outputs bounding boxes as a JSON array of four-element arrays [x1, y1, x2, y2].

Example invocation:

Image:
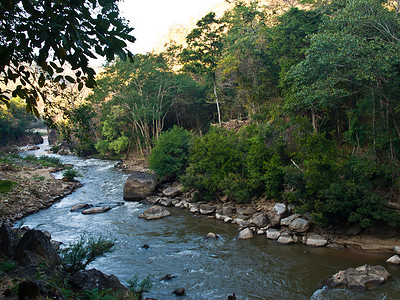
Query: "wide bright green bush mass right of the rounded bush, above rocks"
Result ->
[[181, 125, 286, 202]]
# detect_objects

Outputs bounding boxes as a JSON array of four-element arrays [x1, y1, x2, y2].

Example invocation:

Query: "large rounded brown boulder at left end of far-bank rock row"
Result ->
[[124, 172, 158, 201]]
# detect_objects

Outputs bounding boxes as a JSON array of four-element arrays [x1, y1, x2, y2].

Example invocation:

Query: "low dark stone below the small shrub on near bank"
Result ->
[[69, 269, 129, 292]]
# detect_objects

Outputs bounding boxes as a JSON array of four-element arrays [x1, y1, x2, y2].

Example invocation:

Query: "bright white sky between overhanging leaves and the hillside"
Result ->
[[119, 0, 222, 54]]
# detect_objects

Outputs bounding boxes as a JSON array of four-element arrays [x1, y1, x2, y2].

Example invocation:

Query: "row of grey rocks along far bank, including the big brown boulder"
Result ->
[[124, 172, 329, 246]]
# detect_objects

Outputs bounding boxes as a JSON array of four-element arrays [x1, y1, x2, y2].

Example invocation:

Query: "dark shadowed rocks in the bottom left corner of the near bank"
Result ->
[[0, 223, 129, 299]]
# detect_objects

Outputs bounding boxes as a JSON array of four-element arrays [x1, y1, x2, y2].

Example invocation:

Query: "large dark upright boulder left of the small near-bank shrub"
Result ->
[[15, 229, 60, 268]]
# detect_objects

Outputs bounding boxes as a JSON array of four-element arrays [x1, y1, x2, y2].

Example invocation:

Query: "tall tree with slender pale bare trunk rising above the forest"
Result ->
[[180, 12, 224, 124]]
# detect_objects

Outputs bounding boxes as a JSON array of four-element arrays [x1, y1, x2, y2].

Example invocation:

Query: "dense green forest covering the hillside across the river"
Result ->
[[3, 0, 400, 227]]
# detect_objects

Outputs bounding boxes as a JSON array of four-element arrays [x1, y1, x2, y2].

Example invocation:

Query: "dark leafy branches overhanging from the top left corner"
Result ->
[[0, 0, 135, 116]]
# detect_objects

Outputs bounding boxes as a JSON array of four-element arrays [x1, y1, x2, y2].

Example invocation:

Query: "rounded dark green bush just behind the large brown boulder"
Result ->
[[148, 126, 190, 180]]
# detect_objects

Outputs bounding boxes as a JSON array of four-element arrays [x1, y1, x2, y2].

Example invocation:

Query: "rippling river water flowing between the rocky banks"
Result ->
[[24, 139, 400, 300]]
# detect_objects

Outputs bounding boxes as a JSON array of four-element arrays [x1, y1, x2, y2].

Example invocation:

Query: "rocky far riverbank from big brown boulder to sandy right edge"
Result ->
[[124, 172, 400, 257]]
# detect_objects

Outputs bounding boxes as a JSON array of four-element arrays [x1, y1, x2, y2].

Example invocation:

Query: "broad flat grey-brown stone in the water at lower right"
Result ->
[[327, 265, 392, 290]]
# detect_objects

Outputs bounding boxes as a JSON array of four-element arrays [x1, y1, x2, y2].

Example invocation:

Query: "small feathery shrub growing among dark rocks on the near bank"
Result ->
[[60, 236, 114, 274]]
